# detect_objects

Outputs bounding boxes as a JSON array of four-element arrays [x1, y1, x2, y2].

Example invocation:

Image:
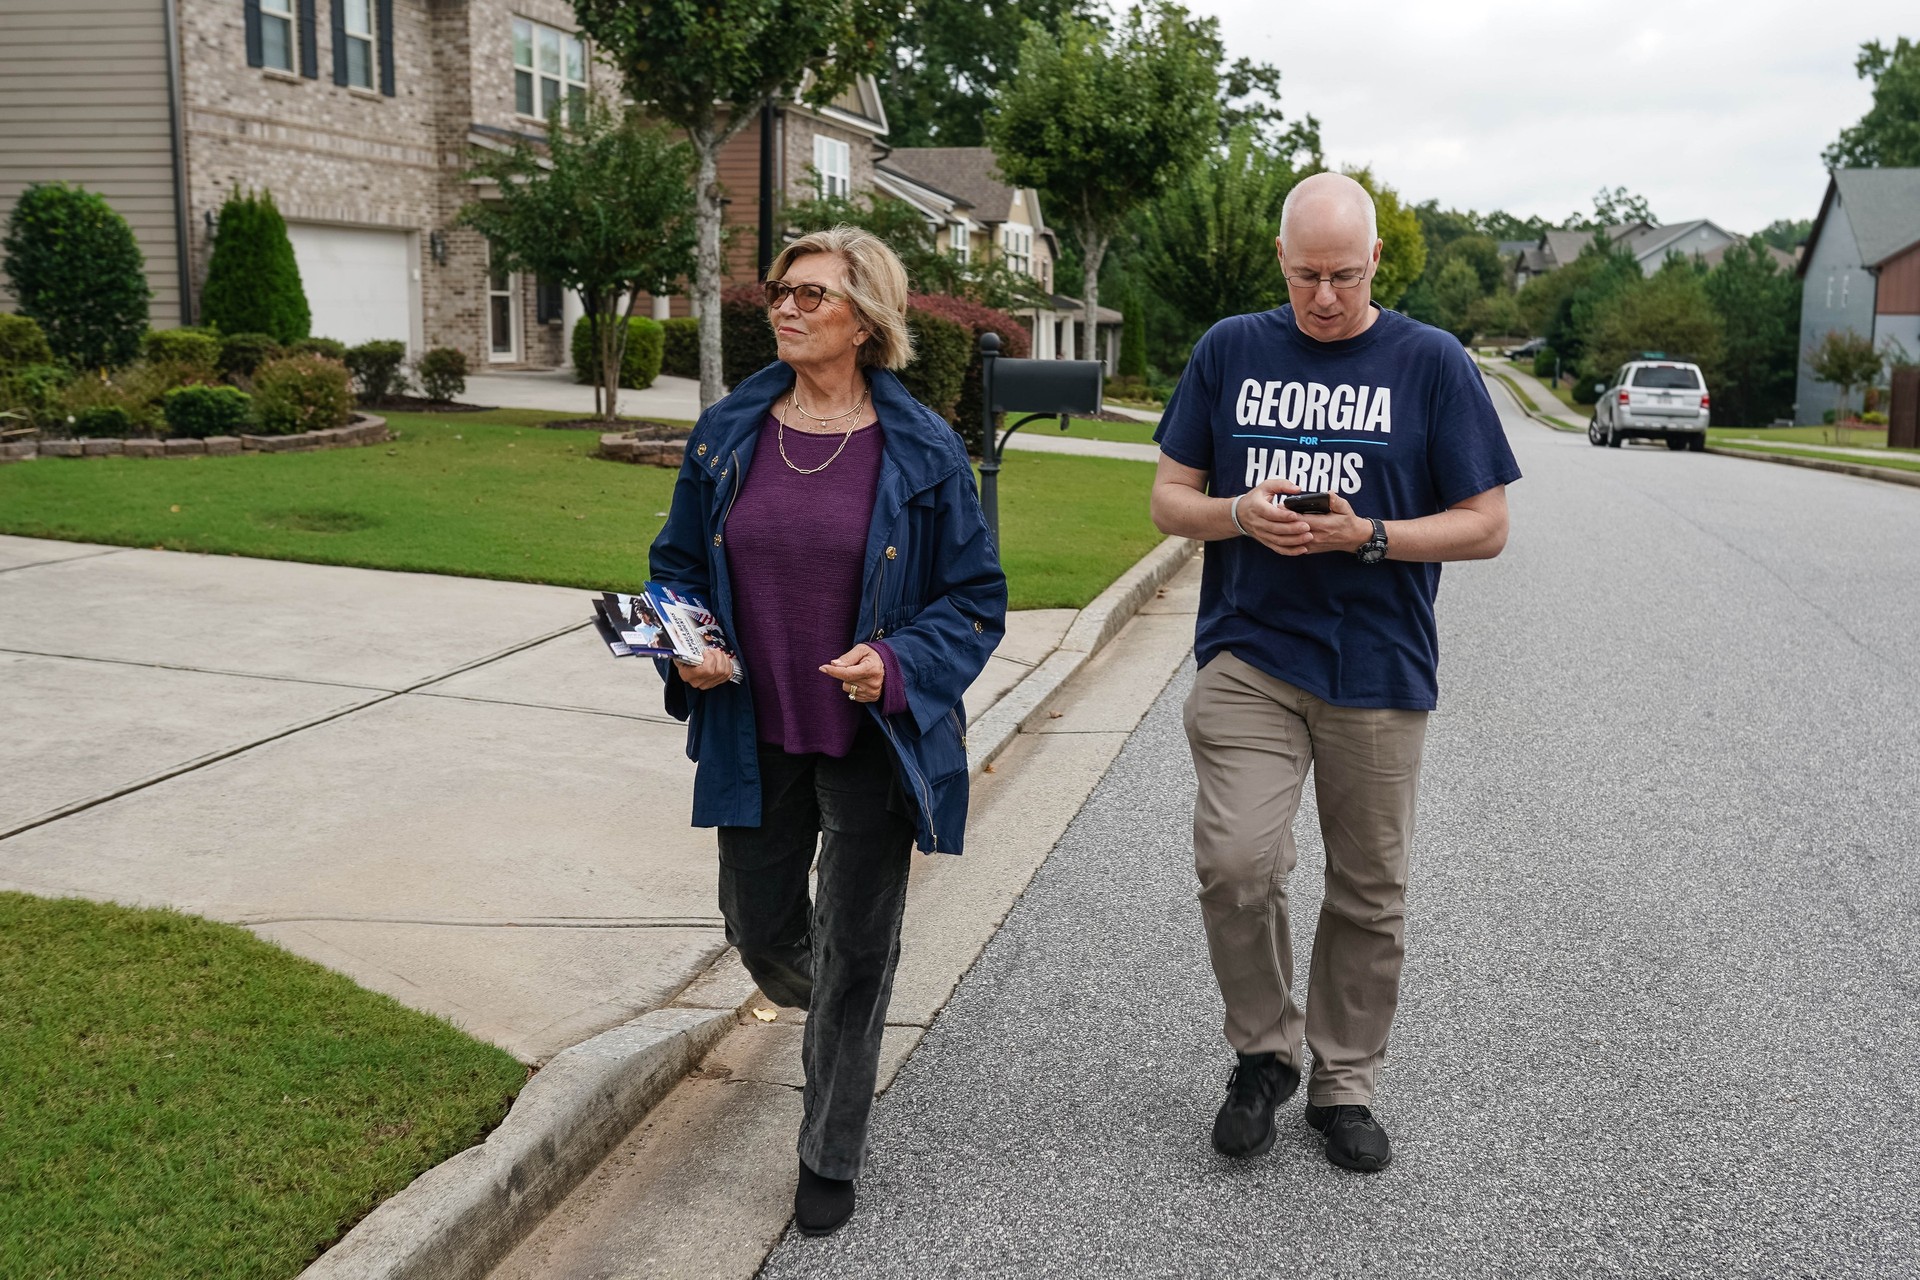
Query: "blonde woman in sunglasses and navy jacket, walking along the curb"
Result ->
[[651, 226, 1006, 1236]]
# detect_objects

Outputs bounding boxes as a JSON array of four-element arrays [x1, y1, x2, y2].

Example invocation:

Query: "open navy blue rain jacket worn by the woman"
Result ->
[[649, 363, 1006, 854]]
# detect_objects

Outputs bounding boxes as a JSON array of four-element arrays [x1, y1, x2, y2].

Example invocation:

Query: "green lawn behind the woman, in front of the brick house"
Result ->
[[0, 411, 1158, 608]]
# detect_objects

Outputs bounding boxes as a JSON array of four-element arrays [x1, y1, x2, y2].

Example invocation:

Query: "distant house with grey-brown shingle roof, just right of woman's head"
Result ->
[[874, 146, 1121, 376]]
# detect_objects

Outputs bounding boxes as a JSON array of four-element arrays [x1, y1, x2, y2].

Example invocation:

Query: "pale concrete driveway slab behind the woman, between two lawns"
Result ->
[[0, 537, 1075, 1063]]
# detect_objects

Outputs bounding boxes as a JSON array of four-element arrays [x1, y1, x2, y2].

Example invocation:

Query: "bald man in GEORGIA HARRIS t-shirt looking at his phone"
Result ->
[[1152, 173, 1521, 1173]]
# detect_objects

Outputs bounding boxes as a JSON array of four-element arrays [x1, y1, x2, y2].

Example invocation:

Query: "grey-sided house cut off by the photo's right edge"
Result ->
[[1795, 169, 1920, 422]]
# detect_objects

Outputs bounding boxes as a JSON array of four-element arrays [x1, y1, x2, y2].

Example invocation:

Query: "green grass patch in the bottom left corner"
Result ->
[[0, 894, 526, 1280]]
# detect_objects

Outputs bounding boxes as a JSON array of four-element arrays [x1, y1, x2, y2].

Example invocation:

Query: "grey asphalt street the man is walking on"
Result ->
[[762, 388, 1920, 1280]]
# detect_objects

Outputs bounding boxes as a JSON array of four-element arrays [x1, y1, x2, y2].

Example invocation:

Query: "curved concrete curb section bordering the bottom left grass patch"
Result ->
[[301, 997, 751, 1280]]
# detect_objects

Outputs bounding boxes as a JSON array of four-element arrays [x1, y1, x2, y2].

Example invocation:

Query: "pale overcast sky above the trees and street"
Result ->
[[1188, 0, 1920, 232]]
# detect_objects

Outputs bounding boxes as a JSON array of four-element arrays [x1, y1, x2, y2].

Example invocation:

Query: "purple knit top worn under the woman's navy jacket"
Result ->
[[726, 415, 906, 756]]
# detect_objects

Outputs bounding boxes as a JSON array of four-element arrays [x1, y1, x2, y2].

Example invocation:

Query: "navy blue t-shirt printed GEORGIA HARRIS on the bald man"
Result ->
[[1154, 305, 1521, 710]]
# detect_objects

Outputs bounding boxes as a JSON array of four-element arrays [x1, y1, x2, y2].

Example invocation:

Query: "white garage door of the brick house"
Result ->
[[286, 223, 417, 347]]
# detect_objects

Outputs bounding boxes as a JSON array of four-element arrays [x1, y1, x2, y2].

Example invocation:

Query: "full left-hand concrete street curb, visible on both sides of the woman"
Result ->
[[301, 537, 1200, 1280]]
